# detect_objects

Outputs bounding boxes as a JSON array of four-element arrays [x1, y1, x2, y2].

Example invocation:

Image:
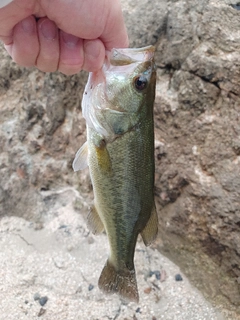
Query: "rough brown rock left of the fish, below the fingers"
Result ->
[[0, 50, 89, 219]]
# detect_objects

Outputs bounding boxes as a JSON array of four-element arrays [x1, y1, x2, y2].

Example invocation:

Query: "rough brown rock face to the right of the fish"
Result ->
[[156, 1, 240, 309]]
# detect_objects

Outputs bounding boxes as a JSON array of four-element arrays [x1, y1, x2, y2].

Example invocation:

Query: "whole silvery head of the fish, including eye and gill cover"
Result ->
[[82, 46, 156, 139]]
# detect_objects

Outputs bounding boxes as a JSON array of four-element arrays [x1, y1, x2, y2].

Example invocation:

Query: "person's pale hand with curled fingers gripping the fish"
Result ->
[[0, 0, 128, 75]]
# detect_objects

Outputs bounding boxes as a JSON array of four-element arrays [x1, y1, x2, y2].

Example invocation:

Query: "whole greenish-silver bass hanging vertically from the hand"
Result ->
[[73, 46, 158, 302]]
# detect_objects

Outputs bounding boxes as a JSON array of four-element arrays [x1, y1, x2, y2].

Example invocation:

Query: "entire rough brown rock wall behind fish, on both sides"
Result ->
[[0, 0, 240, 319]]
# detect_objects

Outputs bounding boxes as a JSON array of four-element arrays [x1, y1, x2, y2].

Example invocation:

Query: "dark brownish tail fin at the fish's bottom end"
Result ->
[[98, 261, 139, 302]]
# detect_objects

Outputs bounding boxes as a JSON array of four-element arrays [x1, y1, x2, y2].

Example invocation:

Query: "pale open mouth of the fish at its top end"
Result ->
[[107, 46, 155, 66]]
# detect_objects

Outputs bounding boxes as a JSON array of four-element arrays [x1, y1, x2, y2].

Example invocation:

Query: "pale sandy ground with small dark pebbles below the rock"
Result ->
[[0, 190, 225, 320]]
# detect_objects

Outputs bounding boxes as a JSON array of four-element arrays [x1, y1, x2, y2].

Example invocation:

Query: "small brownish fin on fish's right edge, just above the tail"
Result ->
[[141, 204, 158, 246]]
